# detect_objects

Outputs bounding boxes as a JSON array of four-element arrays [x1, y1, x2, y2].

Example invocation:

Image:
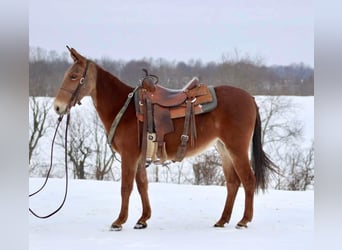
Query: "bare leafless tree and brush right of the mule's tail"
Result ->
[[260, 96, 314, 190]]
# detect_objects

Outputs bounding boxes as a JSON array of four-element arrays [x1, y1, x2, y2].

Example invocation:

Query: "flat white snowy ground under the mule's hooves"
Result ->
[[29, 178, 314, 250]]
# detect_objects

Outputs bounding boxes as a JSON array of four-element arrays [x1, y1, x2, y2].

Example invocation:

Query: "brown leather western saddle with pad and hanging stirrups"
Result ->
[[135, 69, 217, 166]]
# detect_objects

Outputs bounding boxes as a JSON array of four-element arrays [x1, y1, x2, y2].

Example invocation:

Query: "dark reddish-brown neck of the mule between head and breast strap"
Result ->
[[93, 66, 133, 132]]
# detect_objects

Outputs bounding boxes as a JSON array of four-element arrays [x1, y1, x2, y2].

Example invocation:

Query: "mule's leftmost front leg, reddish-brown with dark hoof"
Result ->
[[111, 156, 137, 231]]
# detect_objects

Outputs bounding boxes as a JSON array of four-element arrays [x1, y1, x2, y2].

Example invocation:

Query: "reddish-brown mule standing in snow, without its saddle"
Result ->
[[54, 48, 276, 230]]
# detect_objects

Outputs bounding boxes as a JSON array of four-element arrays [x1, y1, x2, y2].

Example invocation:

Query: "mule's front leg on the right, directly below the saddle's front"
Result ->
[[134, 164, 151, 229]]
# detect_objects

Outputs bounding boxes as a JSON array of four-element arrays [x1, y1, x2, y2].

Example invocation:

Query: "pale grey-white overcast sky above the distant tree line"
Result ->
[[29, 0, 314, 67]]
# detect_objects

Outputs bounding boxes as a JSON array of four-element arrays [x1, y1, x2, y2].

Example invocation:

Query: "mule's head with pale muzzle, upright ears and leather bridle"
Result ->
[[54, 46, 95, 115]]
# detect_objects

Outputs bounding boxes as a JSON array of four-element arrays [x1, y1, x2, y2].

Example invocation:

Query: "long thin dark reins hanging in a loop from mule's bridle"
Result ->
[[29, 113, 70, 219]]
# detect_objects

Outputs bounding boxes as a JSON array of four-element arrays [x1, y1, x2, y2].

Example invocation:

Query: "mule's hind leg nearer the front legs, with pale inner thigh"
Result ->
[[214, 141, 241, 227]]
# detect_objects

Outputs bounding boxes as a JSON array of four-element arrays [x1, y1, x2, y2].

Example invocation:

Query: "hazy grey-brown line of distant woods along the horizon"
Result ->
[[29, 47, 314, 96]]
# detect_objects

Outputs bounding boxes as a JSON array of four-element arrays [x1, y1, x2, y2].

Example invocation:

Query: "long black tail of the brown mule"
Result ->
[[252, 103, 278, 192]]
